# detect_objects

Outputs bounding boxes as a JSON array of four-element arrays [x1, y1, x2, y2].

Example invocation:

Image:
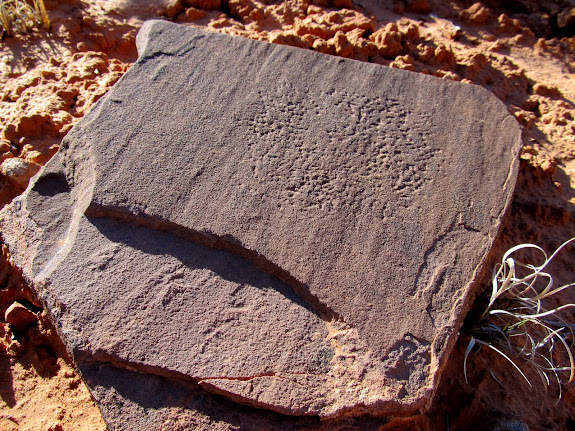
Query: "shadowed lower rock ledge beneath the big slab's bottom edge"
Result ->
[[81, 363, 386, 431]]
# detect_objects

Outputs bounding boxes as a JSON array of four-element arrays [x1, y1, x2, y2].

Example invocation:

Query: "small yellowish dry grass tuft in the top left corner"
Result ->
[[0, 0, 50, 36]]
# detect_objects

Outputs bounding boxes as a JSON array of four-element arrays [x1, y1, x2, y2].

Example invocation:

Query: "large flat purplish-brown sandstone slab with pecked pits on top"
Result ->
[[0, 21, 520, 421]]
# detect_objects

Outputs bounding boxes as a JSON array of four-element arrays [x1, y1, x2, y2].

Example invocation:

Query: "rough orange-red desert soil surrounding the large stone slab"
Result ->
[[0, 0, 575, 431]]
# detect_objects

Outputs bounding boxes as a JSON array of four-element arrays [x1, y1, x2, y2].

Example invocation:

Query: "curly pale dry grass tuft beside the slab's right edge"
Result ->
[[463, 238, 575, 399]]
